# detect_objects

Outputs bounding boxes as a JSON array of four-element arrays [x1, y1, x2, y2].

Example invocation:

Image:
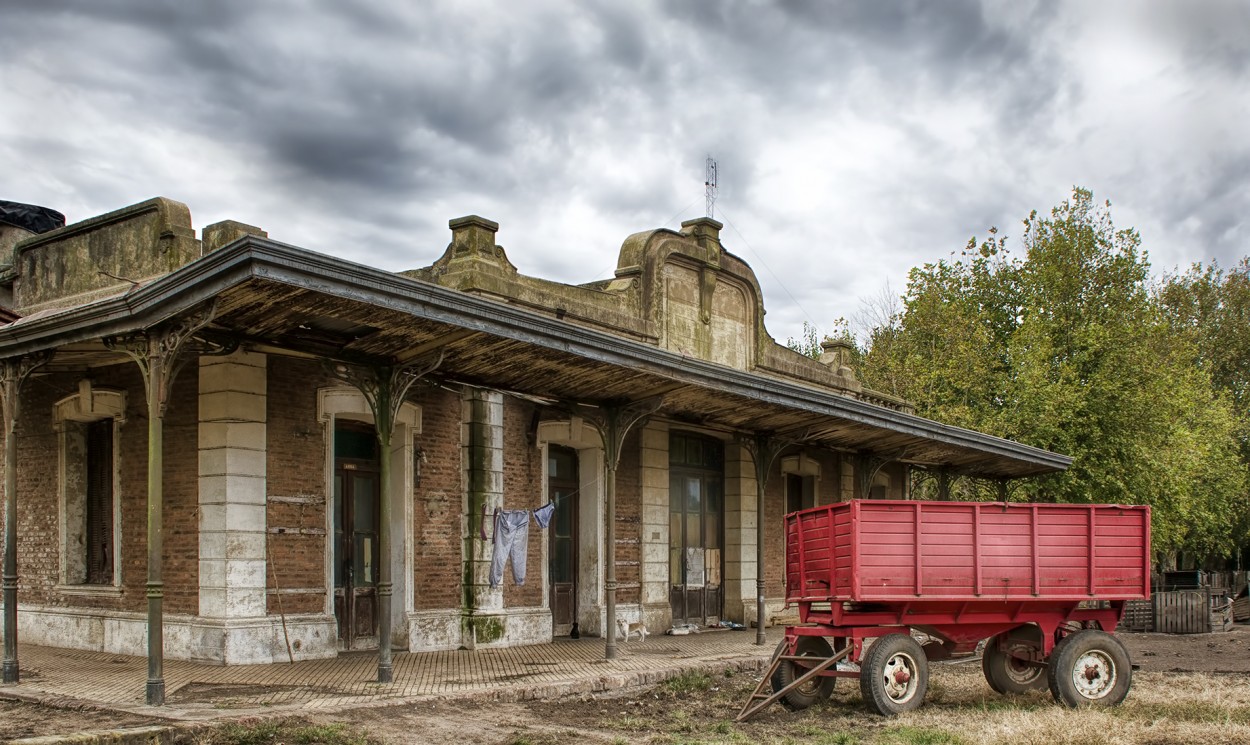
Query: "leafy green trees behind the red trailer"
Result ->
[[861, 189, 1250, 556]]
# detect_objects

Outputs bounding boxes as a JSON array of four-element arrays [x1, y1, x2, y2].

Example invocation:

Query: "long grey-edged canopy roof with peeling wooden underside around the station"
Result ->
[[0, 236, 1071, 478]]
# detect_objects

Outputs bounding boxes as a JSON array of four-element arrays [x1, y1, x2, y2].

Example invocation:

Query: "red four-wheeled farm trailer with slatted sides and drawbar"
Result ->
[[738, 500, 1150, 721]]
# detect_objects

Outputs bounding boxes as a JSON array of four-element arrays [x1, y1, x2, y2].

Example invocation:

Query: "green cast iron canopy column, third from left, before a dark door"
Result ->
[[325, 350, 443, 683]]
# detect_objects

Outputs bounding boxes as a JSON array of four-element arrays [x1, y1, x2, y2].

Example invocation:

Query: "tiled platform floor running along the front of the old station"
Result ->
[[0, 629, 781, 720]]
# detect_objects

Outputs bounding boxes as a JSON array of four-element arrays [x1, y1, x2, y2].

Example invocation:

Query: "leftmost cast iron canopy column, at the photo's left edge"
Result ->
[[0, 353, 51, 683]]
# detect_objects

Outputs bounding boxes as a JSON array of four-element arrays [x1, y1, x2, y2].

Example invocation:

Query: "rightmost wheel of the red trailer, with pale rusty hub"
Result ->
[[1046, 629, 1133, 709]]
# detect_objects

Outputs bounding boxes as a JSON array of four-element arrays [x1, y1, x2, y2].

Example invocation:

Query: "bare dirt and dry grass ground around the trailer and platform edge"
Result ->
[[0, 625, 1250, 745]]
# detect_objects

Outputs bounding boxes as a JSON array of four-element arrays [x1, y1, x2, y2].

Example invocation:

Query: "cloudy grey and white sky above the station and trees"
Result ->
[[0, 0, 1250, 343]]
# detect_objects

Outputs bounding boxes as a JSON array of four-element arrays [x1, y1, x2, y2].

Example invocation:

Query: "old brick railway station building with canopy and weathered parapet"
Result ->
[[0, 199, 1068, 703]]
